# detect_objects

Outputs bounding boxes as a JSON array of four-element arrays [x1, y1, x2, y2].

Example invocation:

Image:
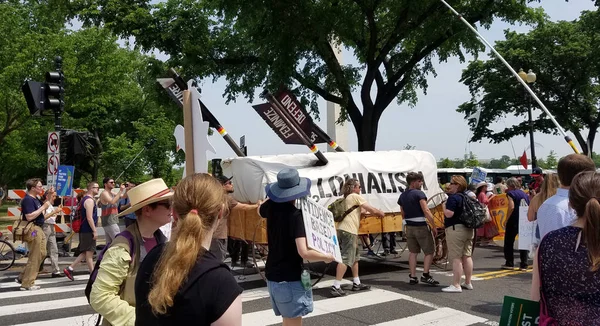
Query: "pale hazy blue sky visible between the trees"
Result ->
[[157, 0, 595, 160]]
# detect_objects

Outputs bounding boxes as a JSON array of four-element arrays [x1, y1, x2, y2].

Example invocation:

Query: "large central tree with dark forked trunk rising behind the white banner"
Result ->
[[71, 0, 542, 151]]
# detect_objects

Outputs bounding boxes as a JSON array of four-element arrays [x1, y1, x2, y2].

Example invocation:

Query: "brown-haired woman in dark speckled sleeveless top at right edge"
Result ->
[[531, 172, 600, 326]]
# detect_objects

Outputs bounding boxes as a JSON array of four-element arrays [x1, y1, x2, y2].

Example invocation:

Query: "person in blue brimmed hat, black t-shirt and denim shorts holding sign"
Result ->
[[258, 169, 334, 326]]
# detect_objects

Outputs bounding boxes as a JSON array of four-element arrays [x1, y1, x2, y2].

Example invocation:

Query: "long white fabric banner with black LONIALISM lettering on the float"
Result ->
[[222, 151, 442, 212]]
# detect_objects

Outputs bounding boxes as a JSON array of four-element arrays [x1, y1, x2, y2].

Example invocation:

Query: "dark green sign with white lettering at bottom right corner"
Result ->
[[499, 296, 540, 326]]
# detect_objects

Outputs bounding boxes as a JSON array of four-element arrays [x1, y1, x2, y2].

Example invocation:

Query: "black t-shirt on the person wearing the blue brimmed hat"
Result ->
[[260, 200, 306, 282]]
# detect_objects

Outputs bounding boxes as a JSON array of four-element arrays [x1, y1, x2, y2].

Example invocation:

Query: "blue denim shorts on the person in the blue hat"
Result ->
[[267, 281, 313, 318]]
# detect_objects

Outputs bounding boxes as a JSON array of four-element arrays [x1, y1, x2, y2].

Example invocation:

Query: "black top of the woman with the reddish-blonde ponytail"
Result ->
[[135, 244, 243, 326]]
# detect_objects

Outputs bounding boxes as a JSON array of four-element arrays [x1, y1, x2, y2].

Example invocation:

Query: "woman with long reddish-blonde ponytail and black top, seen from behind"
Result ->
[[135, 173, 242, 326]]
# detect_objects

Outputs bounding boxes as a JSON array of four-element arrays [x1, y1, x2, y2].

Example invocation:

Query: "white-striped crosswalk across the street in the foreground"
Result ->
[[0, 274, 497, 326]]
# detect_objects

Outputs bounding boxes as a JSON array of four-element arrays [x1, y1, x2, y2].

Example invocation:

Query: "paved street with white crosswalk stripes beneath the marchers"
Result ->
[[0, 239, 531, 326]]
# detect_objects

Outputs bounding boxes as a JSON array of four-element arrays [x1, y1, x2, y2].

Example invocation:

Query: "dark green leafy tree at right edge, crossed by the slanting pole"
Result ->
[[457, 11, 600, 154]]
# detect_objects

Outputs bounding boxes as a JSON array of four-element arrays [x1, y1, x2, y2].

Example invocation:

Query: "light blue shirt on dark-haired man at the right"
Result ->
[[537, 188, 577, 238]]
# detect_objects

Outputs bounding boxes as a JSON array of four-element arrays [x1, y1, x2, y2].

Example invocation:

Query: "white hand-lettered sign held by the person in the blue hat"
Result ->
[[300, 197, 342, 263]]
